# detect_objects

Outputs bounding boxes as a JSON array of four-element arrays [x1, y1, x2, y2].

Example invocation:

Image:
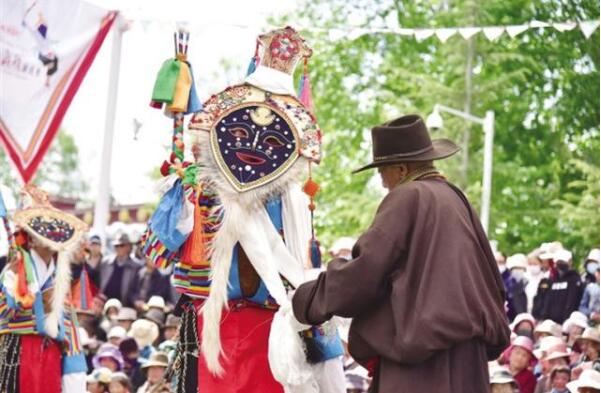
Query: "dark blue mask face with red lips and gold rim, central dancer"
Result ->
[[211, 103, 298, 191]]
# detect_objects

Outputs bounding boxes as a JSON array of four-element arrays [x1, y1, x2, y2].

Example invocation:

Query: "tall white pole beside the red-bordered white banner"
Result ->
[[92, 16, 124, 240]]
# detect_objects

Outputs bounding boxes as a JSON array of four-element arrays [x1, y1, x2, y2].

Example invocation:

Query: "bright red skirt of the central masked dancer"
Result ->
[[198, 301, 284, 393]]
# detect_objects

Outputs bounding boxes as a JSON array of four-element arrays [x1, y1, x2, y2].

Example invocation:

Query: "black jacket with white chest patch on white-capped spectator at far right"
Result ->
[[539, 270, 584, 324]]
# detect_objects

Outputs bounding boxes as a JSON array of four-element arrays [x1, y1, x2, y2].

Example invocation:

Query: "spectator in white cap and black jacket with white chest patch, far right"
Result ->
[[541, 250, 584, 323]]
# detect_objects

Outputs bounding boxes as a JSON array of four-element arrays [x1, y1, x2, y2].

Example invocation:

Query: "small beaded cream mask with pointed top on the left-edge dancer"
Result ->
[[12, 184, 88, 252]]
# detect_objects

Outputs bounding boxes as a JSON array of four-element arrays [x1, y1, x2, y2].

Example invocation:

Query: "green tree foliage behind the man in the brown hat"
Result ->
[[276, 0, 599, 258]]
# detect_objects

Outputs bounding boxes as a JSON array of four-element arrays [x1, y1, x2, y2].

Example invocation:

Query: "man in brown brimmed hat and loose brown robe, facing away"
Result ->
[[293, 115, 510, 393]]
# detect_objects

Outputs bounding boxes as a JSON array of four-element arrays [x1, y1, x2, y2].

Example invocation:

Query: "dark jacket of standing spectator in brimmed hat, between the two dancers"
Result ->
[[100, 257, 140, 307]]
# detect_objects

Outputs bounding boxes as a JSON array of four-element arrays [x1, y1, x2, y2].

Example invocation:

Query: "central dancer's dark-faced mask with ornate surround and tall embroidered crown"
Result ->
[[189, 27, 321, 192]]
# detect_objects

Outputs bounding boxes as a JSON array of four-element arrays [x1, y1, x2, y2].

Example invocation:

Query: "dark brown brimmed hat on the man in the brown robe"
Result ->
[[353, 115, 459, 173]]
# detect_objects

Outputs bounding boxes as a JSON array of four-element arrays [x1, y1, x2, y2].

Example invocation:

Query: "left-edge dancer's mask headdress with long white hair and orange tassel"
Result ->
[[12, 185, 87, 337]]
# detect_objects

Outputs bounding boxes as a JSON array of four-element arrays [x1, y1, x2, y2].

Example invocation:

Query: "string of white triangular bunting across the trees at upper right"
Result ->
[[310, 20, 599, 43]]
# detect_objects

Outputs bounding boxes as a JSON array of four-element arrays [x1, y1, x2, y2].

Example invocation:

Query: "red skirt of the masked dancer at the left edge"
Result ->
[[19, 335, 61, 393]]
